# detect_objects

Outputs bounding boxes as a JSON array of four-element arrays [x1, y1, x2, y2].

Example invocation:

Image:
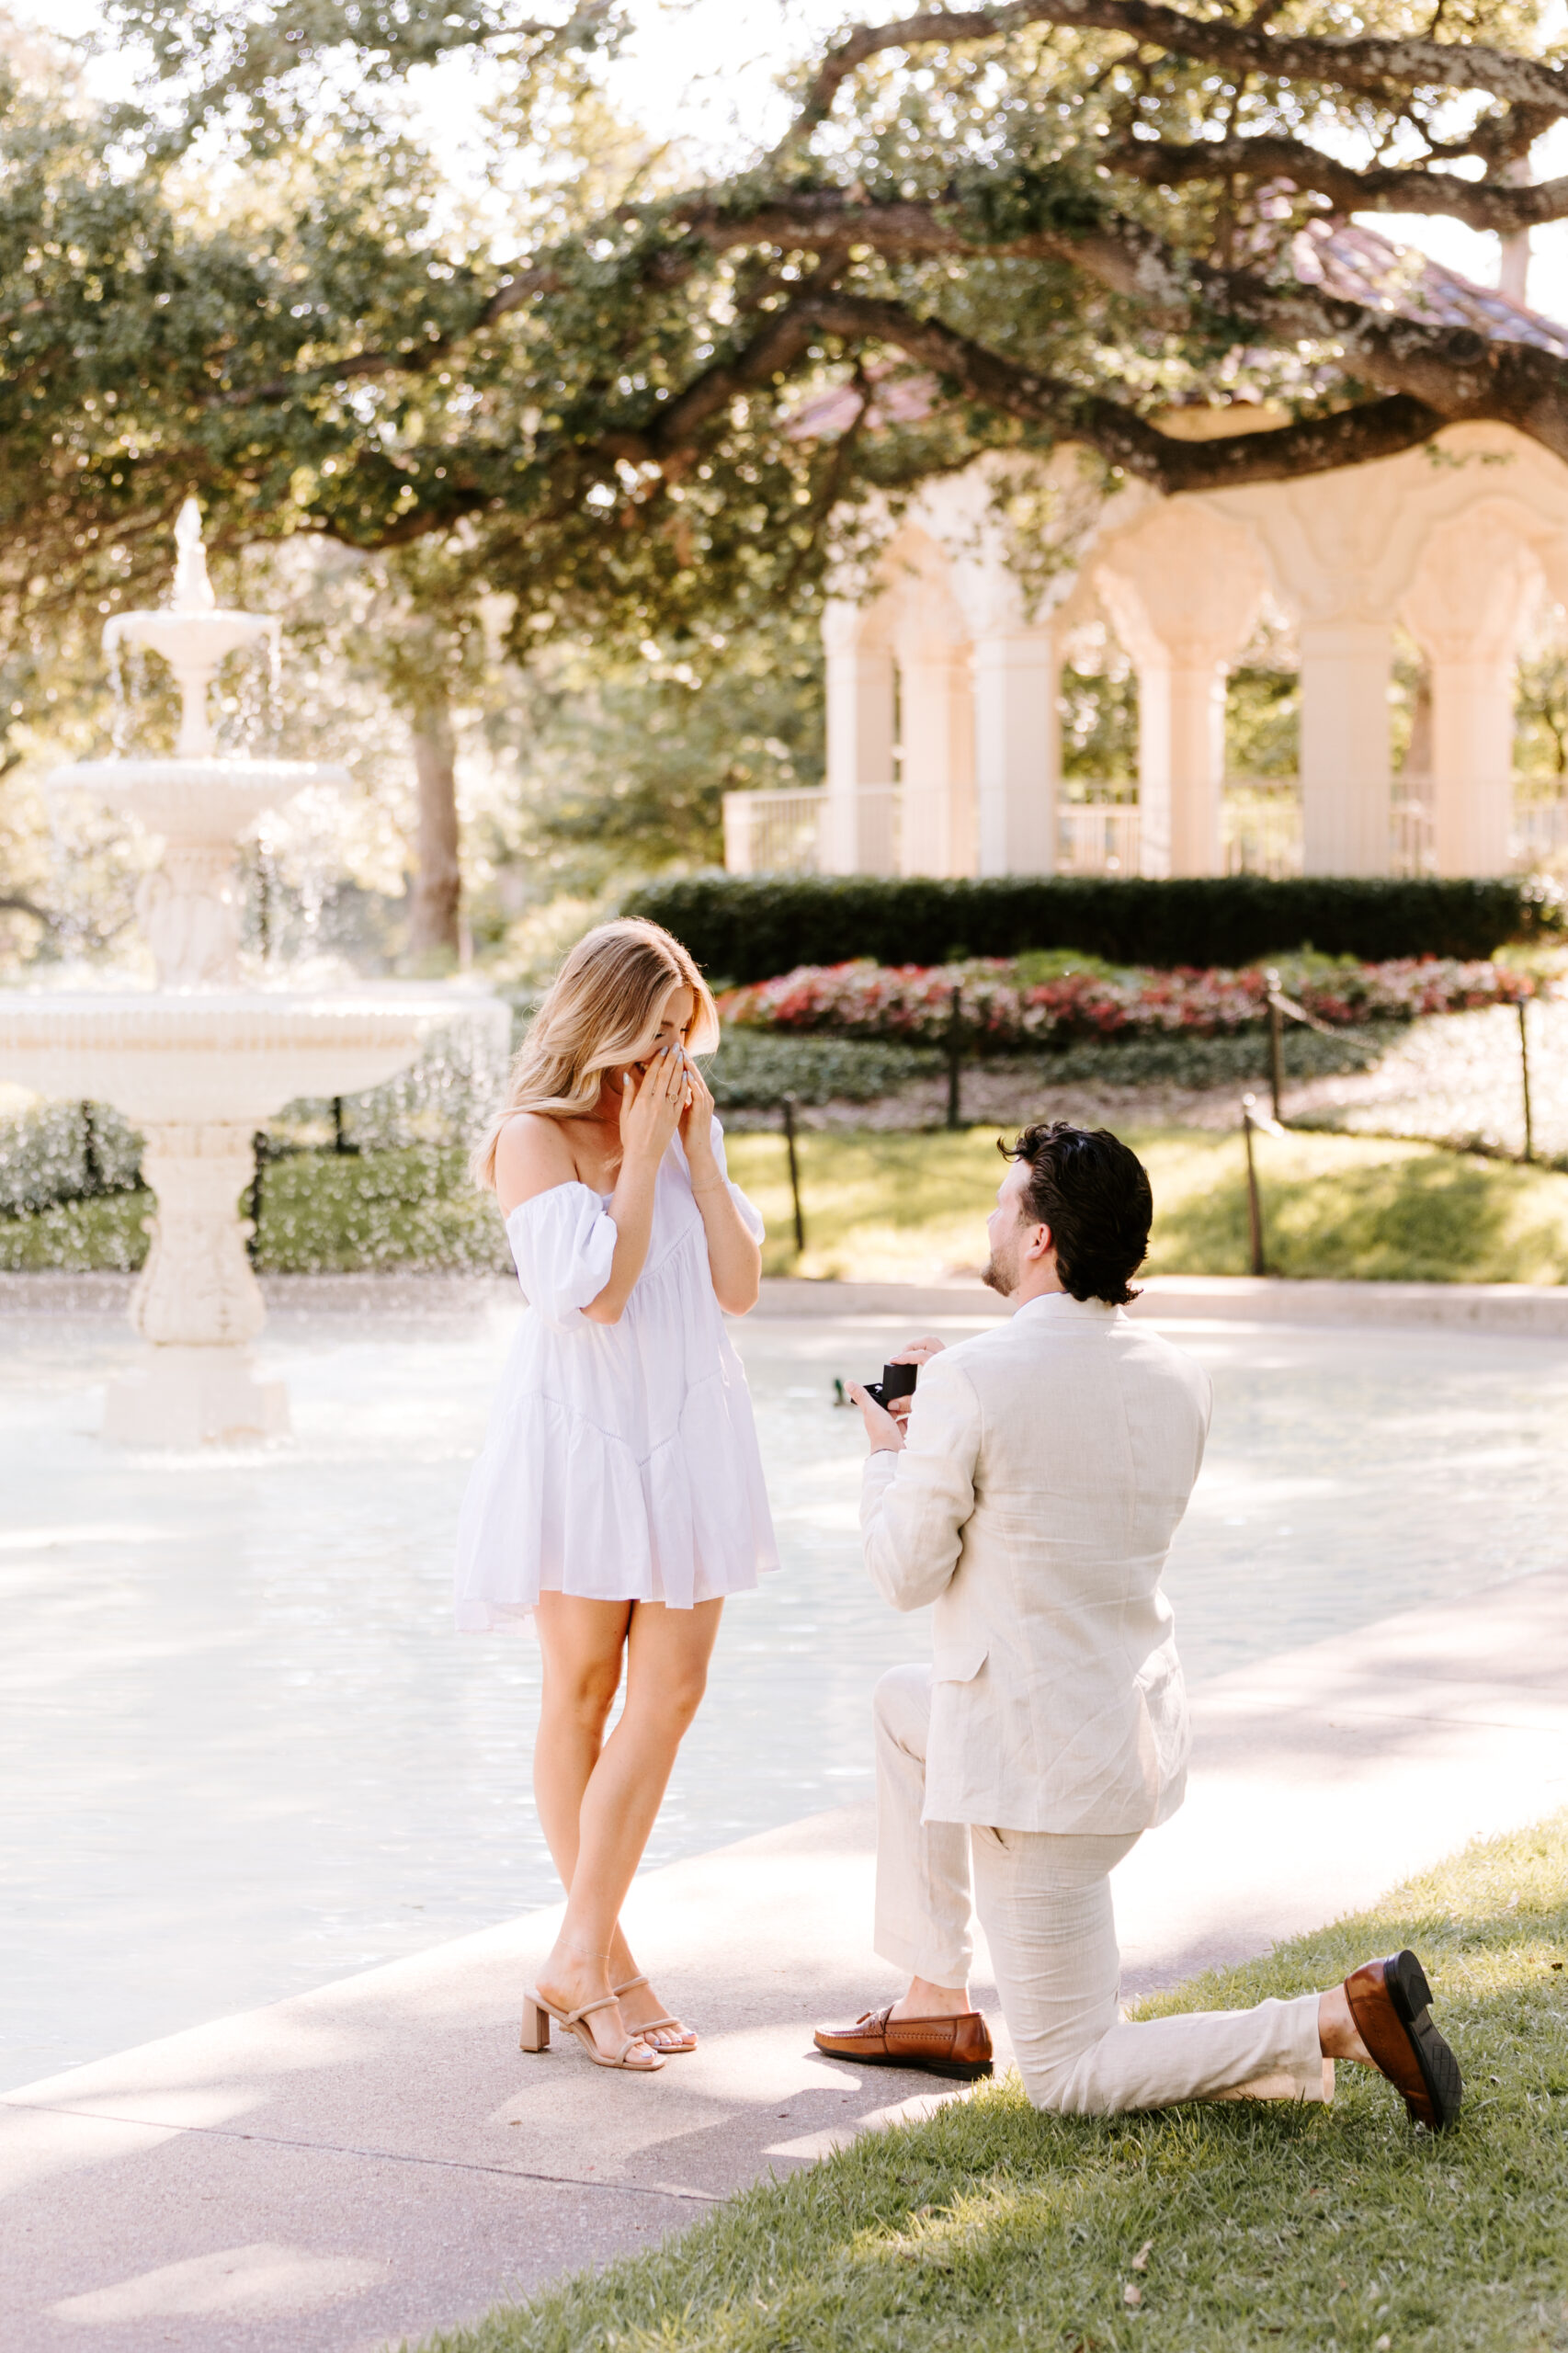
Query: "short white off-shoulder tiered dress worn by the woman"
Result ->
[[457, 1120, 779, 1631]]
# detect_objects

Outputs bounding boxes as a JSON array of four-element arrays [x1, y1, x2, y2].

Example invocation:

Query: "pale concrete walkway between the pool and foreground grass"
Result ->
[[0, 1570, 1568, 2353]]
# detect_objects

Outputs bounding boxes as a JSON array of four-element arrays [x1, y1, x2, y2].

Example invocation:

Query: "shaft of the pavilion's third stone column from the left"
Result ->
[[974, 629, 1062, 875]]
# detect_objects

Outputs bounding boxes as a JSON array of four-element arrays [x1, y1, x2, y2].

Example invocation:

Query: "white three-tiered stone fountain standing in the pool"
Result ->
[[0, 499, 506, 1445]]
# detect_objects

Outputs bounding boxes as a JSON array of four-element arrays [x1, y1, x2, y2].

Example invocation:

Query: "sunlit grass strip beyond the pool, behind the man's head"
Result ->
[[728, 1127, 1568, 1282]]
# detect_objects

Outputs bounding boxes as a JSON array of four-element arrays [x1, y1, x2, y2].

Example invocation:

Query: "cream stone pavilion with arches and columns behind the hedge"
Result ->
[[725, 228, 1568, 875]]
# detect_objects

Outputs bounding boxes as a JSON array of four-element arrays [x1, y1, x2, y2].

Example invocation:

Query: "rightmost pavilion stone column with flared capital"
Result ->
[[1405, 513, 1540, 875]]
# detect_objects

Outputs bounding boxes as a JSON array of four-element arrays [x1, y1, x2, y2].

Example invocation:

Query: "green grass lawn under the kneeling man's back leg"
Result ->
[[428, 1814, 1568, 2353]]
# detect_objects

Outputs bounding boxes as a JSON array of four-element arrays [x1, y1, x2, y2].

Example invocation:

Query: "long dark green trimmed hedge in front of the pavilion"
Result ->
[[621, 875, 1563, 983]]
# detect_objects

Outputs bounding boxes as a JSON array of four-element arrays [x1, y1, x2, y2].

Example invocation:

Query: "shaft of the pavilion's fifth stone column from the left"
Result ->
[[1302, 619, 1393, 875]]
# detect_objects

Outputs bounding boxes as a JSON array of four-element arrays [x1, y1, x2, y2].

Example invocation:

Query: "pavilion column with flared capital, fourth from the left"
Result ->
[[1095, 499, 1267, 875]]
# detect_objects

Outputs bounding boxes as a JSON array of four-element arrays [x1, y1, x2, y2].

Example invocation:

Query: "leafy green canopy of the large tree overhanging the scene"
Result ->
[[15, 0, 1556, 682]]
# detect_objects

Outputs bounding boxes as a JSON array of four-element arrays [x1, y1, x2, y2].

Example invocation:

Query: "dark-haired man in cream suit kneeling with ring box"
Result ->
[[817, 1120, 1460, 2131]]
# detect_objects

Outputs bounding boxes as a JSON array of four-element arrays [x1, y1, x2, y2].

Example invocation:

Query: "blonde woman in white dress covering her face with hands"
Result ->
[[457, 920, 777, 2073]]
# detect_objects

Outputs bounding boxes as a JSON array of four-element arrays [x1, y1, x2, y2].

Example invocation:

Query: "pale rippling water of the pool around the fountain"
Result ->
[[0, 1306, 1568, 2087]]
